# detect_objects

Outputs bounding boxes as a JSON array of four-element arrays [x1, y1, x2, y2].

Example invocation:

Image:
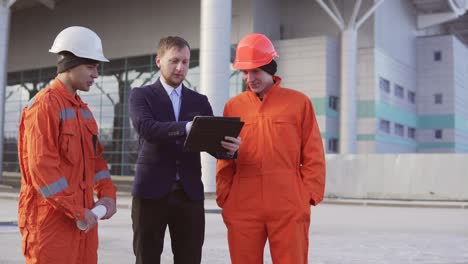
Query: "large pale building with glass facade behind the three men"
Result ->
[[0, 0, 468, 198]]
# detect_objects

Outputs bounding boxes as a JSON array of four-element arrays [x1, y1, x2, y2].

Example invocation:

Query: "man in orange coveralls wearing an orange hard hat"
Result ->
[[216, 34, 325, 264]]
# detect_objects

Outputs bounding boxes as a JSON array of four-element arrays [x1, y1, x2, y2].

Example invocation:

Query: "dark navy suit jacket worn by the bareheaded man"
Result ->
[[129, 79, 221, 200]]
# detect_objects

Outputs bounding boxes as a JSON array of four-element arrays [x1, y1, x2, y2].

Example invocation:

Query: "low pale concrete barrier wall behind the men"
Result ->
[[1, 153, 468, 201]]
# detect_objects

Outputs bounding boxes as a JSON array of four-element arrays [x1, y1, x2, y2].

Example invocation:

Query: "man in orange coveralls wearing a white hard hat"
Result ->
[[18, 27, 116, 264]]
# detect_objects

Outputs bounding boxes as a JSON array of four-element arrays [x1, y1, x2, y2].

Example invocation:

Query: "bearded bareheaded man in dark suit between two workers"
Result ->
[[129, 36, 240, 264]]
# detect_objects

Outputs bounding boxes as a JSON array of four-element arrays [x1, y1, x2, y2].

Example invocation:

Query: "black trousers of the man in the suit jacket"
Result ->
[[132, 190, 205, 264]]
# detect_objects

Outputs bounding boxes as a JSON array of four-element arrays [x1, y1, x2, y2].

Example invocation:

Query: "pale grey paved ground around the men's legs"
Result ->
[[0, 193, 468, 264]]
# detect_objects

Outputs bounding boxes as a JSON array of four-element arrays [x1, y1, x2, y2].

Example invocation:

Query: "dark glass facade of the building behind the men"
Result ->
[[3, 50, 243, 176]]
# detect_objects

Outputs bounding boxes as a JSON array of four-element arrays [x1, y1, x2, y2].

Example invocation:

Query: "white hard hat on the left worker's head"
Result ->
[[49, 26, 109, 62]]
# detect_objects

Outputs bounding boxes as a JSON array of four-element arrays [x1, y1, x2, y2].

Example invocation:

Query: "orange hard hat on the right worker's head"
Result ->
[[233, 33, 278, 70]]
